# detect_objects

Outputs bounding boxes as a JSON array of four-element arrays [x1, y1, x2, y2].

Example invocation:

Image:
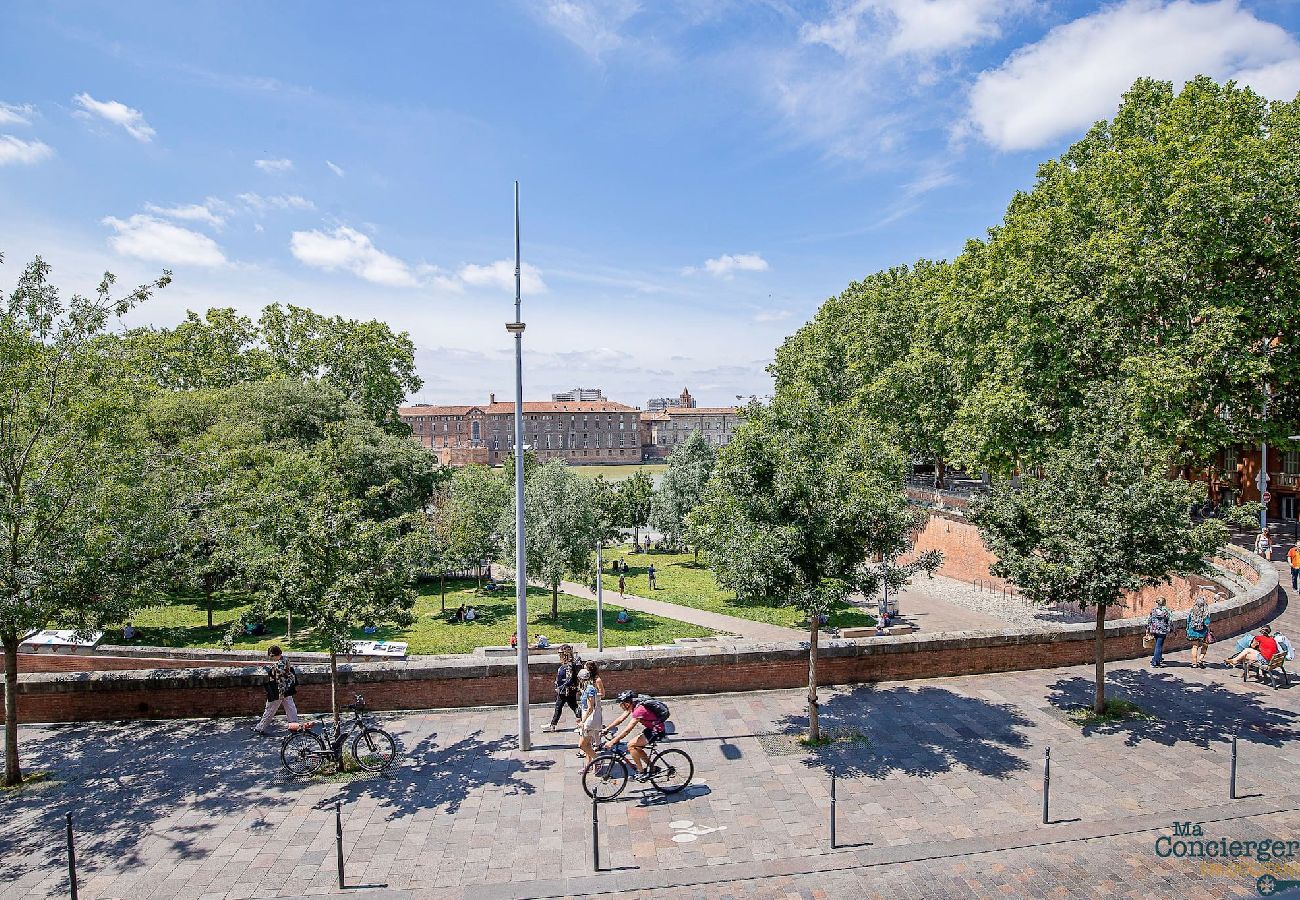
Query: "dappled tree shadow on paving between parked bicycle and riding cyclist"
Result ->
[[320, 731, 555, 821]]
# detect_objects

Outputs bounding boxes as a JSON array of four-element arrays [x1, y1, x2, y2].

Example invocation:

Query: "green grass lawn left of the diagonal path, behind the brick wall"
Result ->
[[115, 580, 712, 654]]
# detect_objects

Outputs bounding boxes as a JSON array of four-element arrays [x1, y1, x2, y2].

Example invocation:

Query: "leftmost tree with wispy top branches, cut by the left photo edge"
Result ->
[[0, 256, 170, 786]]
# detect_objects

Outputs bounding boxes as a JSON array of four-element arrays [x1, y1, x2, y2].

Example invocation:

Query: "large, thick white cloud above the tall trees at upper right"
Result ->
[[970, 0, 1300, 151]]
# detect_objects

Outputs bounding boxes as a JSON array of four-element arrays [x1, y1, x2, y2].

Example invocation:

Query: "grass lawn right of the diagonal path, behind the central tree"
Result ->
[[605, 548, 876, 628]]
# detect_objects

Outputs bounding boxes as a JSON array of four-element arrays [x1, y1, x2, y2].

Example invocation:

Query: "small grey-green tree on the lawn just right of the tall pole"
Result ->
[[498, 459, 607, 621]]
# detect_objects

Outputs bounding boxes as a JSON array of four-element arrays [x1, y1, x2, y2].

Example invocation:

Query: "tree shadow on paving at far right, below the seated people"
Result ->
[[1048, 670, 1300, 749]]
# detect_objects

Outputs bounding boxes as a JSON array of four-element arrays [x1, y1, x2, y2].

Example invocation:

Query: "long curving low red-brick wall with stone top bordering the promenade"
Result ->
[[5, 549, 1278, 722]]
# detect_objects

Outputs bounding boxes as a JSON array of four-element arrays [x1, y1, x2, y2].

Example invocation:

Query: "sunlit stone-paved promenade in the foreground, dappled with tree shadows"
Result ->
[[0, 567, 1300, 900]]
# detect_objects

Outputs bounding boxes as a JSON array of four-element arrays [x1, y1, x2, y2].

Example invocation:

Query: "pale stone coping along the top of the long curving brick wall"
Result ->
[[18, 548, 1278, 696]]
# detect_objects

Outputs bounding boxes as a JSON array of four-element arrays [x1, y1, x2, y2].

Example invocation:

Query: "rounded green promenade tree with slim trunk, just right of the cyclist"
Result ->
[[689, 384, 939, 741]]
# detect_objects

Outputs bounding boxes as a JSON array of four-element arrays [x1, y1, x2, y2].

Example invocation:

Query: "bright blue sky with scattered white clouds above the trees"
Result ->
[[0, 0, 1300, 404]]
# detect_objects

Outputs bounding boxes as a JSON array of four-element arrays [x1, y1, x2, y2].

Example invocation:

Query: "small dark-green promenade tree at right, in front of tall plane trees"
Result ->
[[970, 391, 1227, 714]]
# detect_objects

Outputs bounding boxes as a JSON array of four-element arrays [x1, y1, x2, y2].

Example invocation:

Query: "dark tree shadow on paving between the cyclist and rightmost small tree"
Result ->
[[777, 684, 1034, 779]]
